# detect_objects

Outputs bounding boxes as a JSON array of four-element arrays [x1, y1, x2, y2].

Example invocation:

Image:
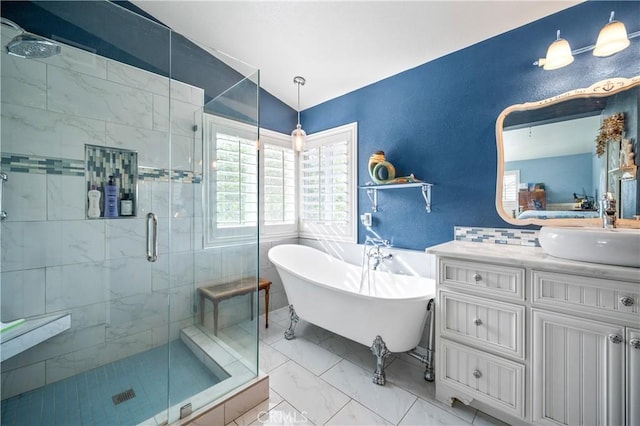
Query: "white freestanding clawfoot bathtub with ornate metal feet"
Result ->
[[269, 244, 436, 384]]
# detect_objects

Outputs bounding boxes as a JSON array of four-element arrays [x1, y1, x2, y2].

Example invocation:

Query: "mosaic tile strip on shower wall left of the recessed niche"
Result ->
[[0, 153, 84, 176]]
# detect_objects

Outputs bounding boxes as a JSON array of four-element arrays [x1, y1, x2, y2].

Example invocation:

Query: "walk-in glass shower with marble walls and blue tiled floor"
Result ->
[[0, 1, 259, 425]]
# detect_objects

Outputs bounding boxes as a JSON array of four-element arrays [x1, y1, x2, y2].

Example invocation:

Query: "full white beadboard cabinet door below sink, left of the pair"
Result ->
[[533, 310, 625, 426]]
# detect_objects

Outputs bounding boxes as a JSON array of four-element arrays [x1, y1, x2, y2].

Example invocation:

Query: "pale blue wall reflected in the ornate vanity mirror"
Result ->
[[505, 153, 595, 203]]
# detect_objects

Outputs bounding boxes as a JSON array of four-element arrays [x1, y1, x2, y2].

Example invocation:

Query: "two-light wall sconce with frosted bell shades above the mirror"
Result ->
[[533, 11, 640, 70]]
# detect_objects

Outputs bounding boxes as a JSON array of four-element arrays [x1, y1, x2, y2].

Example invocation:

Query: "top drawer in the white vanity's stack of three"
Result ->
[[439, 258, 524, 300]]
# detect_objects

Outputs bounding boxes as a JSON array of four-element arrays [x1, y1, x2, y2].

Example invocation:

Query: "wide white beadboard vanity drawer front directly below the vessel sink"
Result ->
[[531, 270, 640, 324]]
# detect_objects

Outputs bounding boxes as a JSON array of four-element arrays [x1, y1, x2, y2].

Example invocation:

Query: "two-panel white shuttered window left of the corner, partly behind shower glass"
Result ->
[[203, 115, 298, 247]]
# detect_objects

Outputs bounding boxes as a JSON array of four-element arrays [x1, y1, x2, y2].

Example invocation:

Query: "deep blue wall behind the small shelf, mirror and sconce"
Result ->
[[301, 1, 640, 249]]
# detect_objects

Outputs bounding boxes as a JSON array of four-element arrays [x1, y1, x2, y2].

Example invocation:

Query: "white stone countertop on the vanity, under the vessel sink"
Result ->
[[426, 241, 640, 285]]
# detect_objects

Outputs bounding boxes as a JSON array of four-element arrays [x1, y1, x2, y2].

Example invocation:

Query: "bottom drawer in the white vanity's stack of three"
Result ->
[[436, 339, 525, 418]]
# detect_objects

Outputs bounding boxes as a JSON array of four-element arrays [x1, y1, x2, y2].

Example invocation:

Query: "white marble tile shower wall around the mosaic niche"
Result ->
[[0, 35, 272, 398]]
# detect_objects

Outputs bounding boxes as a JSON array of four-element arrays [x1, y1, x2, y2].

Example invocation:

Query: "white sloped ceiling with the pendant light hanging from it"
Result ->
[[133, 0, 581, 110]]
